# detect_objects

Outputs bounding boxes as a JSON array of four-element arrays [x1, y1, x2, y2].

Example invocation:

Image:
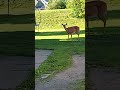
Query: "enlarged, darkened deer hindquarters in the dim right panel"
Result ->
[[85, 0, 107, 30]]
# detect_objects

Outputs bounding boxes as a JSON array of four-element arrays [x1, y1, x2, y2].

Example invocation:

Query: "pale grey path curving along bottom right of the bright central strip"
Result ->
[[35, 55, 85, 90]]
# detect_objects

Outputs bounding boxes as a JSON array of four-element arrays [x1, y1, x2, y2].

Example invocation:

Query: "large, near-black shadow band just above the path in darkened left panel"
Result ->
[[0, 31, 35, 56]]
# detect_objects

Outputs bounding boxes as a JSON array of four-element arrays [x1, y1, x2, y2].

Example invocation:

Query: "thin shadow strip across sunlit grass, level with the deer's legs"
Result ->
[[35, 30, 85, 36]]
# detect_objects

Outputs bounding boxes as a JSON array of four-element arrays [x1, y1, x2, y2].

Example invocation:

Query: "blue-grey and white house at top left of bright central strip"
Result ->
[[35, 0, 48, 10]]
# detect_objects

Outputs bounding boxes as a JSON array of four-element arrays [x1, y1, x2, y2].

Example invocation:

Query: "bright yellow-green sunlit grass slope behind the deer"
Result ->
[[35, 9, 85, 32]]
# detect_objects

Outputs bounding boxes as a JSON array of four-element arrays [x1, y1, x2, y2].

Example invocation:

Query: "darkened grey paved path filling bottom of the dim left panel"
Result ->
[[0, 55, 35, 90]]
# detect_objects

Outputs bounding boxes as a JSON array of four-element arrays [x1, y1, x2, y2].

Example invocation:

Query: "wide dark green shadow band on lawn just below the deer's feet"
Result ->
[[35, 37, 85, 50]]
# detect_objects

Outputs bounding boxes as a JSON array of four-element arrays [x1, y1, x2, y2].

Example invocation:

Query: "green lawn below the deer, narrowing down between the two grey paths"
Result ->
[[35, 36, 85, 76]]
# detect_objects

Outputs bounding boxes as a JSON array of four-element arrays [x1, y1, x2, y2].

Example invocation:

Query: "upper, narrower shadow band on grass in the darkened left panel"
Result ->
[[0, 14, 35, 24]]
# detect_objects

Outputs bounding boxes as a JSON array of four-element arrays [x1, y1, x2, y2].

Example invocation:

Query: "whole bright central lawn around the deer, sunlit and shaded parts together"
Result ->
[[35, 10, 85, 77]]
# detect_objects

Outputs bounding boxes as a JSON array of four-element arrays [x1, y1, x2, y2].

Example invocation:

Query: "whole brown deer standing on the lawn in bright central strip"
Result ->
[[62, 23, 80, 39]]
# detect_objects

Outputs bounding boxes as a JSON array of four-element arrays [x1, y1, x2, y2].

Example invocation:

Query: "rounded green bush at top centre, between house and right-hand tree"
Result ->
[[48, 0, 66, 9]]
